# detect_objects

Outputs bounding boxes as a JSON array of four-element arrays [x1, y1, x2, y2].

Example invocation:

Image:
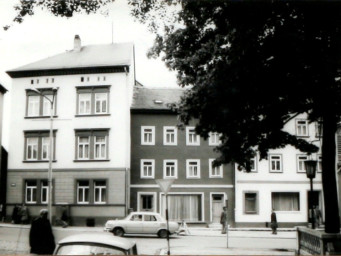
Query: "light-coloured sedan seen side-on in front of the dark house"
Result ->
[[104, 212, 179, 238]]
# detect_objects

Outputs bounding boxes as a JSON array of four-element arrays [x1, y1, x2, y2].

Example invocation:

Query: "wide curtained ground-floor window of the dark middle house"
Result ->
[[162, 194, 203, 222]]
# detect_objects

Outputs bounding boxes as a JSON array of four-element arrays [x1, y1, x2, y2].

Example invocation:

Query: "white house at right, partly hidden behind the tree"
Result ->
[[235, 115, 324, 227]]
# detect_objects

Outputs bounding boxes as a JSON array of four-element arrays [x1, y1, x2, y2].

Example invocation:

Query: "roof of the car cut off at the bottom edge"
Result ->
[[58, 233, 135, 250]]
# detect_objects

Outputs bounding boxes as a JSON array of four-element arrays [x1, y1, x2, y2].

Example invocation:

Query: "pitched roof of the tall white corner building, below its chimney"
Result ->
[[7, 43, 134, 77]]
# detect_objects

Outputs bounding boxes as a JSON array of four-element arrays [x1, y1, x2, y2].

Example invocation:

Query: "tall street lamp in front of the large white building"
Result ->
[[31, 87, 58, 224]]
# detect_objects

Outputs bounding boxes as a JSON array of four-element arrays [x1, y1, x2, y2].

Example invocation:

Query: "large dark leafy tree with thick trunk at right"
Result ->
[[7, 0, 341, 233]]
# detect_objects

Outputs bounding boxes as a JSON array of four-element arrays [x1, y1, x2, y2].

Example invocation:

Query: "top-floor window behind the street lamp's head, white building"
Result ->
[[26, 88, 57, 117]]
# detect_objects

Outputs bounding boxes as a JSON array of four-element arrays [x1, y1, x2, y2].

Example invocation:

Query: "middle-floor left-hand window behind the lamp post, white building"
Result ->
[[24, 131, 56, 161]]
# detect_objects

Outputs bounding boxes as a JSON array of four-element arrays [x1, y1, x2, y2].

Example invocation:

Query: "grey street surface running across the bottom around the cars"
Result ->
[[0, 225, 296, 255]]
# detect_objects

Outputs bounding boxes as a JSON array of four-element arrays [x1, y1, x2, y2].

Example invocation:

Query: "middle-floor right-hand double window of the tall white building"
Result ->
[[75, 129, 109, 161]]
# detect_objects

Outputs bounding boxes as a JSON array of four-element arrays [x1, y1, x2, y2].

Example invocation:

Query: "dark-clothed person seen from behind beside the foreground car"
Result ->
[[29, 209, 56, 254]]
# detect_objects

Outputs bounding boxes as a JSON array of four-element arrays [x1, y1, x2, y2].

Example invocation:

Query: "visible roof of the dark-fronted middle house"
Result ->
[[131, 86, 185, 112]]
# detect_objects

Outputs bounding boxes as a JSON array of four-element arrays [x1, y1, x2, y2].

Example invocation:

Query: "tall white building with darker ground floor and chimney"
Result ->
[[7, 36, 135, 225]]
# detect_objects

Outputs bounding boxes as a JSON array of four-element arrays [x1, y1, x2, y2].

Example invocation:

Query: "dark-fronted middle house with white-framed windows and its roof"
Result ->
[[130, 86, 234, 224]]
